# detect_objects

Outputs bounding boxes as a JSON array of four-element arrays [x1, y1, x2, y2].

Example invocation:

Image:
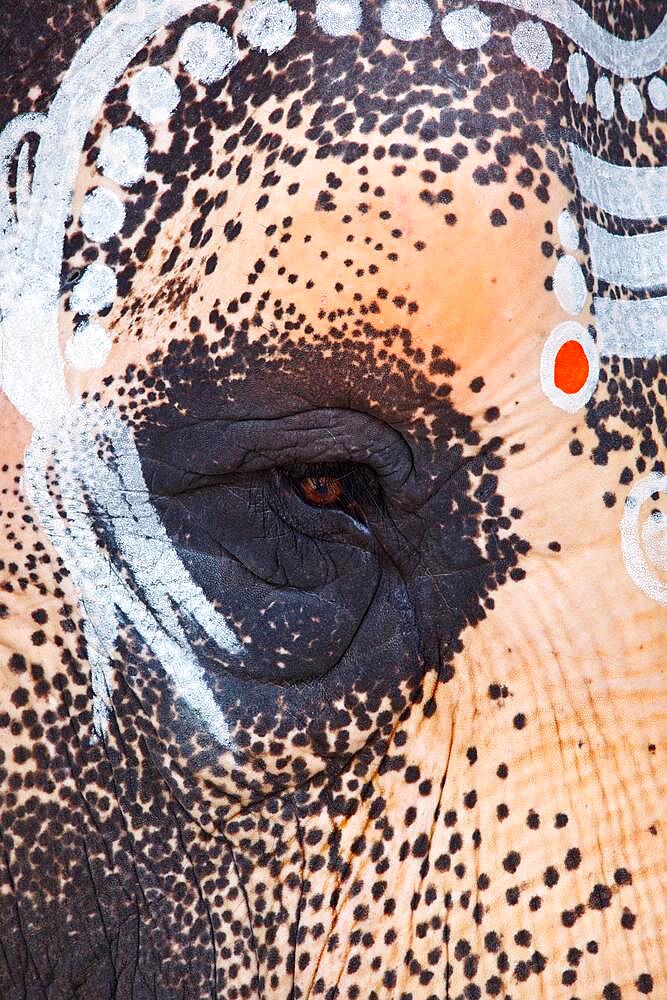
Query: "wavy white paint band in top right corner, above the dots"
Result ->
[[487, 0, 667, 77]]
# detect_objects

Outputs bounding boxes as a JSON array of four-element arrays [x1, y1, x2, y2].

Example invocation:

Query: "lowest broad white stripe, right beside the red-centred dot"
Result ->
[[593, 296, 667, 358]]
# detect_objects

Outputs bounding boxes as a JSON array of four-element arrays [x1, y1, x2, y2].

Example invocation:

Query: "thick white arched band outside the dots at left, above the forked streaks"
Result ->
[[0, 0, 202, 426]]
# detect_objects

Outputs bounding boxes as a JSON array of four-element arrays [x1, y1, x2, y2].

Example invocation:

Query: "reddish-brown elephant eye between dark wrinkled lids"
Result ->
[[280, 462, 381, 524]]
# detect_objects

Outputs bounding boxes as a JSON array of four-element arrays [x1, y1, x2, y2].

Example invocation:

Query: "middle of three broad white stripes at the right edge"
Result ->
[[586, 219, 667, 288]]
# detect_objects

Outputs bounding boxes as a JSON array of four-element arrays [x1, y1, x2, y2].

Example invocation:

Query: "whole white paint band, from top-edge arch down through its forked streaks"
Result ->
[[0, 0, 241, 745]]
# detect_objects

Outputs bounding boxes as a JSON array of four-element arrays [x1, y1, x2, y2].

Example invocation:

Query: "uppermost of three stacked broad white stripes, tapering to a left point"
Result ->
[[568, 142, 667, 219]]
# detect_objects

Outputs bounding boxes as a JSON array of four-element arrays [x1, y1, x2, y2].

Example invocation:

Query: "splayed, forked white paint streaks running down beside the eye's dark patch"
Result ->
[[24, 407, 241, 746]]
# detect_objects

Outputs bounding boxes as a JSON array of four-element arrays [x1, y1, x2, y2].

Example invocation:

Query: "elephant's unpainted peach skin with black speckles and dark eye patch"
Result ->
[[0, 4, 667, 1000]]
